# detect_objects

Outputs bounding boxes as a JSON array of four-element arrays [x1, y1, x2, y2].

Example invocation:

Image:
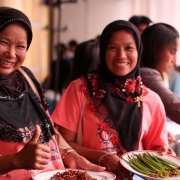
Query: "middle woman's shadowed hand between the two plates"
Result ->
[[100, 154, 132, 180]]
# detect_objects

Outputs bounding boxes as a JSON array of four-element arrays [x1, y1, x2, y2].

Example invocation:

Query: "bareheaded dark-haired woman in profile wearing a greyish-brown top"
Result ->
[[140, 23, 180, 124]]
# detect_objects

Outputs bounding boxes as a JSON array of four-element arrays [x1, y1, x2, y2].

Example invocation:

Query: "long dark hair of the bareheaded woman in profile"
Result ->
[[141, 23, 179, 69]]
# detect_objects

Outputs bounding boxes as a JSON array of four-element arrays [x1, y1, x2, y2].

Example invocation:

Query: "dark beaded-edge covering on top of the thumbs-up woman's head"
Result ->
[[0, 7, 32, 49]]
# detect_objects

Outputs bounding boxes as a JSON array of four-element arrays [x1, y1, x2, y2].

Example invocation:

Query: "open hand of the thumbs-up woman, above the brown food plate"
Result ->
[[64, 152, 106, 171]]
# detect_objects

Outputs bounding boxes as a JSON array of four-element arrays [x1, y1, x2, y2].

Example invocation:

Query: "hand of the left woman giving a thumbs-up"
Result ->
[[13, 125, 51, 170]]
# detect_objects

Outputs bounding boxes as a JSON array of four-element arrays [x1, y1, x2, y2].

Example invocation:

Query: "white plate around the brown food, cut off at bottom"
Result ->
[[32, 169, 116, 180]]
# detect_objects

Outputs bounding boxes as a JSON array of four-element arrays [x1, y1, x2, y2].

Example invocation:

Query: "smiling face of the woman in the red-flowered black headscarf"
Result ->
[[105, 30, 138, 76]]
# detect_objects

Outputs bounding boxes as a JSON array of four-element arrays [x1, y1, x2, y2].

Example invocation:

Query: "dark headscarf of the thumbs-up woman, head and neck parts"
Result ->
[[0, 6, 32, 97]]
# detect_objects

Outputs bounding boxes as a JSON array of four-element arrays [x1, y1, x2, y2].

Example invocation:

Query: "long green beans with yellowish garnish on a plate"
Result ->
[[125, 153, 180, 178]]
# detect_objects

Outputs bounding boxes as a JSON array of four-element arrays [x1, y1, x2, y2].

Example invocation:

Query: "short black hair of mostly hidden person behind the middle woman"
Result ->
[[129, 16, 152, 26]]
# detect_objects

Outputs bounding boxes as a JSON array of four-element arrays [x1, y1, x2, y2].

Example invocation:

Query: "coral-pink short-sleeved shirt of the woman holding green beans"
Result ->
[[51, 79, 168, 151]]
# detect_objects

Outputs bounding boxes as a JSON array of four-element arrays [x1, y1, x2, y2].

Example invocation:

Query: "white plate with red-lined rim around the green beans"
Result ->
[[120, 151, 180, 180]]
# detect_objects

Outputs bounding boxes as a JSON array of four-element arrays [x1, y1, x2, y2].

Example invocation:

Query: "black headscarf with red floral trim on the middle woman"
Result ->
[[85, 20, 143, 151]]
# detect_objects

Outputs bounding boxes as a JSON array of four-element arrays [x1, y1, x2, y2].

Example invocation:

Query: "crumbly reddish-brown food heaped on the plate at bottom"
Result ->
[[49, 170, 97, 180]]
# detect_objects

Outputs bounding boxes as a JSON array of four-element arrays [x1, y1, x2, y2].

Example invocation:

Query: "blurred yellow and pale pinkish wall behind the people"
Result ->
[[0, 0, 180, 82]]
